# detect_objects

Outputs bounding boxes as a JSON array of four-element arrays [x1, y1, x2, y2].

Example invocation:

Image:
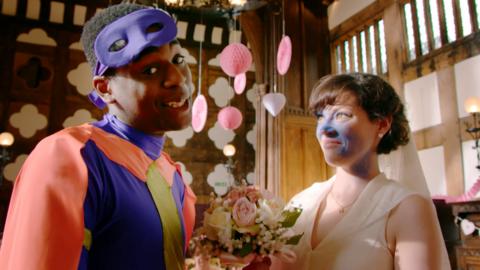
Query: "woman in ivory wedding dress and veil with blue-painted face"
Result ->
[[249, 73, 450, 270]]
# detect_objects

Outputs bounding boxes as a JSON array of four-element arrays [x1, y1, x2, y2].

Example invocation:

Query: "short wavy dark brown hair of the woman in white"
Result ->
[[309, 73, 410, 154]]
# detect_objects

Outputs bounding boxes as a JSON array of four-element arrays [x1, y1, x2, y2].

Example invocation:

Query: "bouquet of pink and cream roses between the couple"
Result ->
[[191, 186, 303, 265]]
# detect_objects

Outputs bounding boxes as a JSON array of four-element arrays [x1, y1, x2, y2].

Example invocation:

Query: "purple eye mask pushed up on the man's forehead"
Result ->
[[94, 8, 177, 75]]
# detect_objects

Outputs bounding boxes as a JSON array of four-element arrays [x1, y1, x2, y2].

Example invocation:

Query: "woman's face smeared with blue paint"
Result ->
[[316, 91, 380, 167]]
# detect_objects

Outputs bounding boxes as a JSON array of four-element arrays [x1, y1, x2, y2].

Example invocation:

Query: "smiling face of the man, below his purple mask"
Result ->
[[109, 43, 193, 135]]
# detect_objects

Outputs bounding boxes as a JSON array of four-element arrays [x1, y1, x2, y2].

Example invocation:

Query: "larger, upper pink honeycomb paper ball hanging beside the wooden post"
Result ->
[[220, 43, 252, 77]]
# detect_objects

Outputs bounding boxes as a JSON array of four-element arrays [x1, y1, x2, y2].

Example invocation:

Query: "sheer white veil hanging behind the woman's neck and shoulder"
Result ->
[[379, 133, 430, 198]]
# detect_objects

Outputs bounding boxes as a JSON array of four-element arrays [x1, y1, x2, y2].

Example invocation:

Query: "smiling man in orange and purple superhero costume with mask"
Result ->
[[0, 4, 195, 270]]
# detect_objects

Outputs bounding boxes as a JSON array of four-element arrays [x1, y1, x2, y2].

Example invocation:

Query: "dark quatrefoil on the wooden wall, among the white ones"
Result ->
[[17, 57, 51, 88]]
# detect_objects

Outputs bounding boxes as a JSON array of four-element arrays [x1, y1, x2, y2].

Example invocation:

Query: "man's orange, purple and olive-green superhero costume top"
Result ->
[[0, 114, 195, 269]]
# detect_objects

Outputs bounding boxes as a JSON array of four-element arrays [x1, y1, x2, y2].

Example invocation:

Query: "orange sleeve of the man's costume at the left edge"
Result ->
[[0, 125, 91, 270]]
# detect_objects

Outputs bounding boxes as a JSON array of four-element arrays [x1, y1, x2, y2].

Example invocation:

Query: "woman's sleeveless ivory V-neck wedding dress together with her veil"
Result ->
[[271, 140, 450, 270]]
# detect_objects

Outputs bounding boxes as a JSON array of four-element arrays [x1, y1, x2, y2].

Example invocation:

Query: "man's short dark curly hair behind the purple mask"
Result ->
[[80, 3, 148, 68]]
